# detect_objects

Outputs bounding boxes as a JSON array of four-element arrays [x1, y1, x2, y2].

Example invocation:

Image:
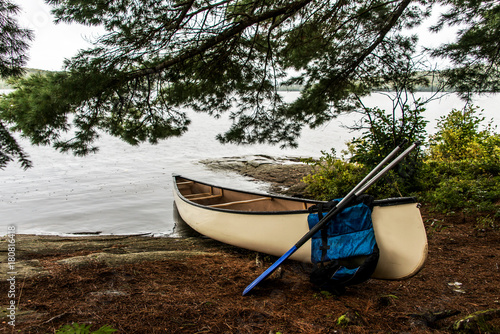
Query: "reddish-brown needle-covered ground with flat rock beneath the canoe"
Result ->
[[0, 162, 500, 334]]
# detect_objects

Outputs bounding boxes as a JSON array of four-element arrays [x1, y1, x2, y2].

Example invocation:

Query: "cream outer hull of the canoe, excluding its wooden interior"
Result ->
[[174, 176, 427, 279]]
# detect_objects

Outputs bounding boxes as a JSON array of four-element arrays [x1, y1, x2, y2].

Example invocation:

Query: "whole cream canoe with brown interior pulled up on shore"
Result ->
[[173, 175, 427, 280]]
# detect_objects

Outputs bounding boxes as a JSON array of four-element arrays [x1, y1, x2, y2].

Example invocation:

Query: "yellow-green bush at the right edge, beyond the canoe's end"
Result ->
[[421, 107, 500, 216]]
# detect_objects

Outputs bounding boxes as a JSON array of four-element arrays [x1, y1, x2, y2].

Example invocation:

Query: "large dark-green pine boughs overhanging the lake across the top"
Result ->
[[0, 0, 427, 158]]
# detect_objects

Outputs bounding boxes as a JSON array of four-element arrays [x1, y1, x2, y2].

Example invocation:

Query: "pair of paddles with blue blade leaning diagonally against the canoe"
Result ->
[[243, 140, 420, 296]]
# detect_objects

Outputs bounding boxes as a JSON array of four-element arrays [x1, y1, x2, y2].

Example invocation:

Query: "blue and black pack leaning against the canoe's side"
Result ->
[[307, 195, 379, 294]]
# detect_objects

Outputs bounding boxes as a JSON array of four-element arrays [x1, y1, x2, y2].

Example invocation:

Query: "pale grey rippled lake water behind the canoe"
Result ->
[[0, 92, 500, 236]]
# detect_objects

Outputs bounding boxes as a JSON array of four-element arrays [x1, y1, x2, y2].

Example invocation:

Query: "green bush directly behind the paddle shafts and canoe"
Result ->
[[304, 100, 427, 200]]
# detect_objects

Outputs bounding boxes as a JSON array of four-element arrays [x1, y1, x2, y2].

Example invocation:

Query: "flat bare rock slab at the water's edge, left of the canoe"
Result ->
[[0, 234, 235, 281]]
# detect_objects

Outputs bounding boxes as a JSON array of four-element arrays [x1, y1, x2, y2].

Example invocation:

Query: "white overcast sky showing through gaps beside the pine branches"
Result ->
[[13, 0, 453, 71]]
